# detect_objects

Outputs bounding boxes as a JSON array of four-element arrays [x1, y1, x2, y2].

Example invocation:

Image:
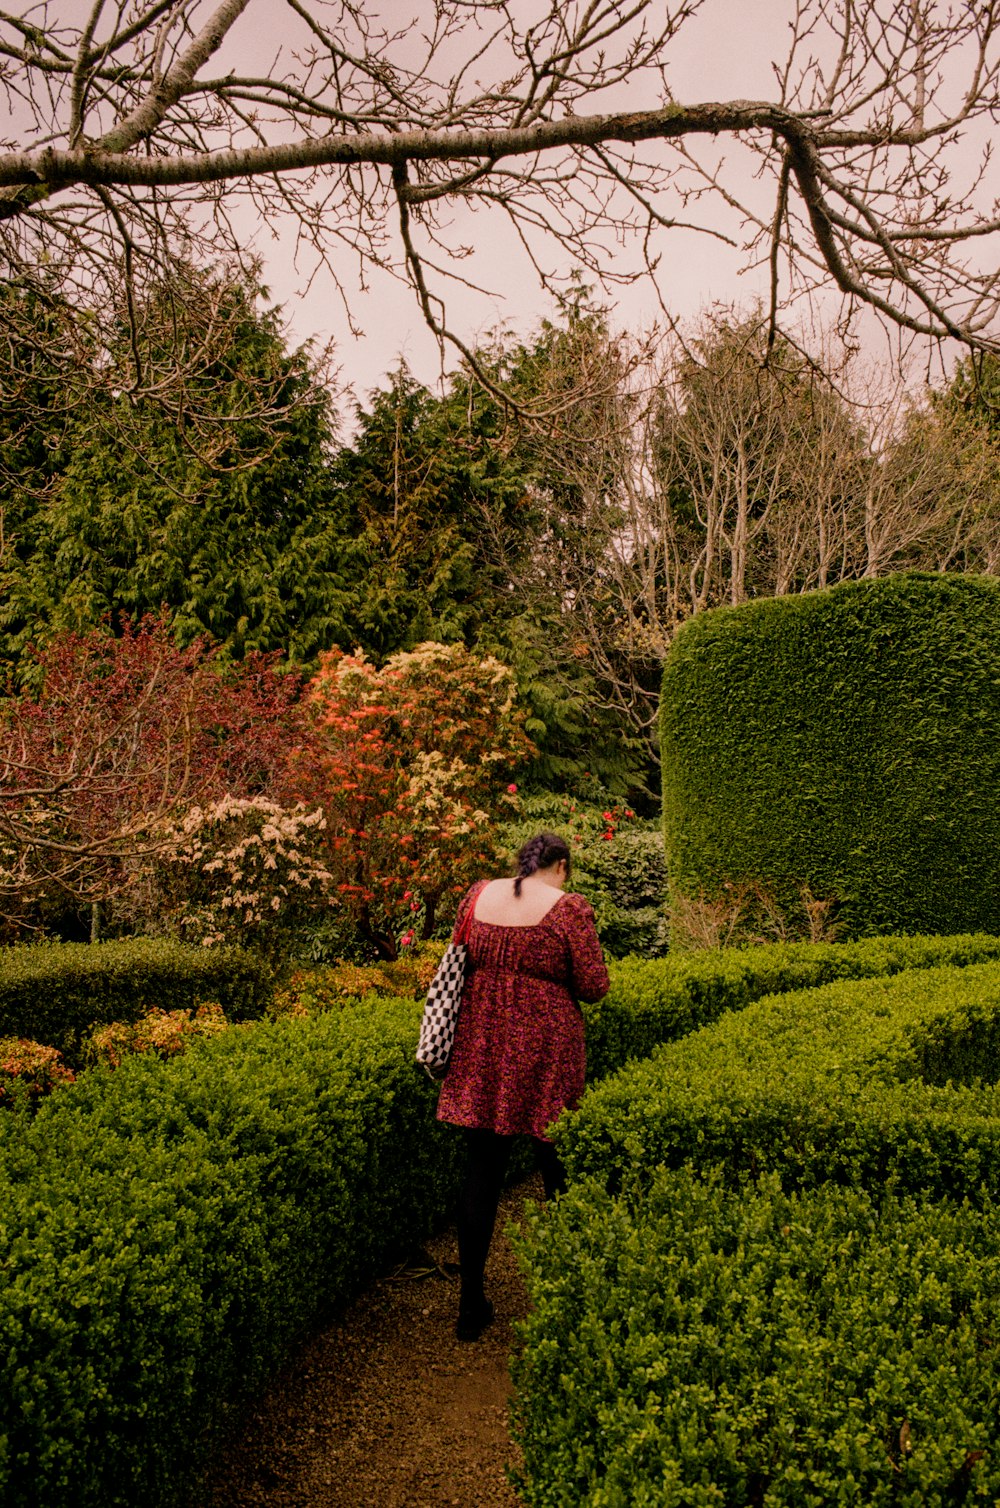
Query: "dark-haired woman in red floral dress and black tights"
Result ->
[[437, 832, 608, 1341]]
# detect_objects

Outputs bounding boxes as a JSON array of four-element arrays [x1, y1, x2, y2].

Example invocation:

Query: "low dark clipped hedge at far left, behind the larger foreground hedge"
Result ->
[[0, 938, 273, 1066]]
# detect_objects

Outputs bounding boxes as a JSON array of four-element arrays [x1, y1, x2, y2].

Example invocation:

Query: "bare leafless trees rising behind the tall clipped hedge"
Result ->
[[484, 308, 1000, 734]]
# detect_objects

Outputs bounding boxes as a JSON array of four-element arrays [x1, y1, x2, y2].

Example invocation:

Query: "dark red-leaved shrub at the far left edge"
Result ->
[[0, 617, 300, 920]]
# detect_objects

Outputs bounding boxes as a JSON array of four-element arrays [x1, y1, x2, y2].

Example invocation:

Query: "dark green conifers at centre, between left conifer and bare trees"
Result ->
[[333, 351, 649, 792]]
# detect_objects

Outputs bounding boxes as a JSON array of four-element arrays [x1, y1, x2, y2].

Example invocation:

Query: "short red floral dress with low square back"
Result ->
[[437, 881, 608, 1137]]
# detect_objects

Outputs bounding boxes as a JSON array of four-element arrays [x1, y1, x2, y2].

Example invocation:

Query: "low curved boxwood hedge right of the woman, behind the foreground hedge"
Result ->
[[555, 962, 1000, 1199]]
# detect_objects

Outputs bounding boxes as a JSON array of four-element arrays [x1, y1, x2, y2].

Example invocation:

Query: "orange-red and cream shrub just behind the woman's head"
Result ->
[[288, 644, 534, 958]]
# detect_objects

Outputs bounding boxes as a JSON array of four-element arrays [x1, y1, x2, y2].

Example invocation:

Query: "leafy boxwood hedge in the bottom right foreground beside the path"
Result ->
[[514, 1169, 1000, 1508]]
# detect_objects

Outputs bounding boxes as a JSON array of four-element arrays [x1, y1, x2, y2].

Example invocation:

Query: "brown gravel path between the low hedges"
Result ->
[[198, 1179, 541, 1508]]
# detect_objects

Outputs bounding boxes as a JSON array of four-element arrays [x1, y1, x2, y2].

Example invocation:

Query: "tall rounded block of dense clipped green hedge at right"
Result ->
[[661, 575, 1000, 936]]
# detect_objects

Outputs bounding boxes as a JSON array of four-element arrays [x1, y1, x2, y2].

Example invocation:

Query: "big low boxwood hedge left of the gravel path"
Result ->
[[0, 1001, 460, 1508]]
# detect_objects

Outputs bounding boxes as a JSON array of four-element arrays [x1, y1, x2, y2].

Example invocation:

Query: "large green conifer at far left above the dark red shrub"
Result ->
[[0, 274, 357, 670]]
